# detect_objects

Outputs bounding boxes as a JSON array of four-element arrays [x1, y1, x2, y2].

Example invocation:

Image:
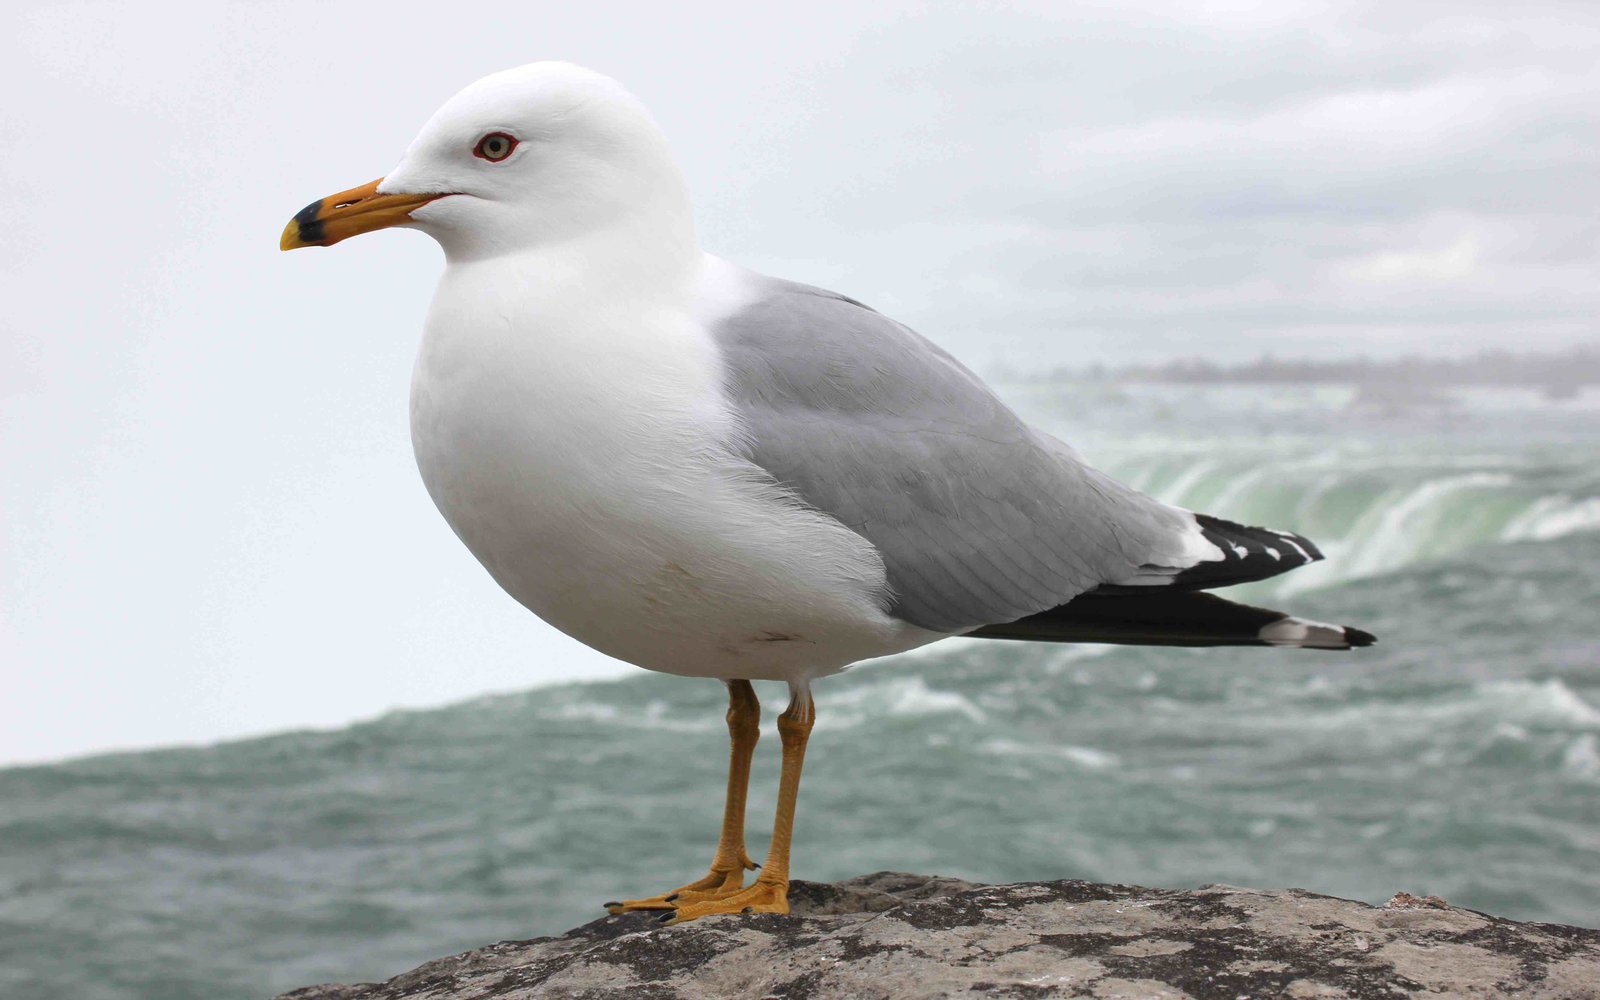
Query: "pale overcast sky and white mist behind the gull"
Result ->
[[0, 0, 1600, 763]]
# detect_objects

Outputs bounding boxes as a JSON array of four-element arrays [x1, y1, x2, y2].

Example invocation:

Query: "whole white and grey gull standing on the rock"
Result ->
[[280, 62, 1374, 923]]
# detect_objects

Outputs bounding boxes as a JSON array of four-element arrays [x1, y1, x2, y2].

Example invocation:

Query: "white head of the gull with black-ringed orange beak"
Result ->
[[278, 62, 688, 259]]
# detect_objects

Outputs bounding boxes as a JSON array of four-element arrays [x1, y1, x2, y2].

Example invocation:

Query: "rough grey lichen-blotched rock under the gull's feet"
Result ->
[[278, 872, 1600, 1000]]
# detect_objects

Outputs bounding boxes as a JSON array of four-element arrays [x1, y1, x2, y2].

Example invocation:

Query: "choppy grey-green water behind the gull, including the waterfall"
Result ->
[[0, 377, 1600, 1000]]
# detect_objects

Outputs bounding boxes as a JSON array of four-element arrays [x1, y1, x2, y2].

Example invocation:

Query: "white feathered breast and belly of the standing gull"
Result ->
[[411, 258, 936, 678]]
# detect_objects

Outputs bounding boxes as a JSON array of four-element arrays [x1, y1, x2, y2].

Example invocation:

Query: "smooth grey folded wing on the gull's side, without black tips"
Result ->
[[712, 270, 1205, 632]]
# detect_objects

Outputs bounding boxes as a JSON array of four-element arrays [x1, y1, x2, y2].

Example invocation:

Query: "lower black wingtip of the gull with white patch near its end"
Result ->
[[966, 589, 1378, 650]]
